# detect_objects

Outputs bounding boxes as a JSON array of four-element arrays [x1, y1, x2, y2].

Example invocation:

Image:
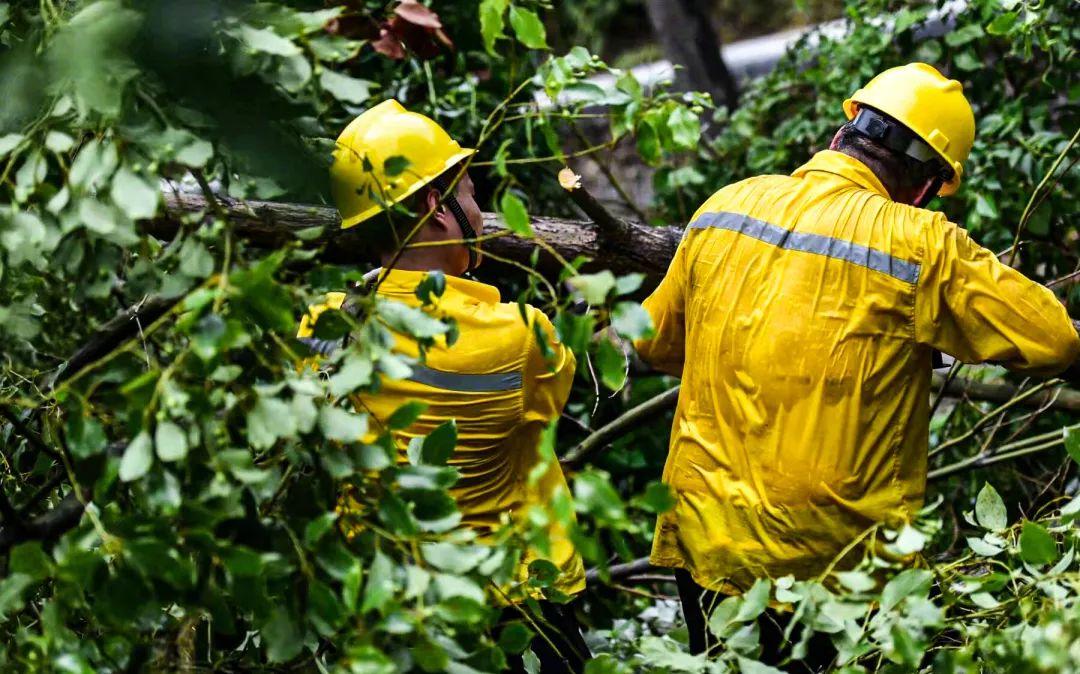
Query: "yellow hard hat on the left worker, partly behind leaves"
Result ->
[[330, 98, 476, 228]]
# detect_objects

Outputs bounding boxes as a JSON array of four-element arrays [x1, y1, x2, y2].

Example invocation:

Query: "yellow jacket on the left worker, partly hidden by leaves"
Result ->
[[297, 269, 585, 595]]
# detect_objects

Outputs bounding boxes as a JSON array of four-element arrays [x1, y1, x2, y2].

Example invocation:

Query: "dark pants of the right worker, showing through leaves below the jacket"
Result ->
[[675, 569, 836, 674]]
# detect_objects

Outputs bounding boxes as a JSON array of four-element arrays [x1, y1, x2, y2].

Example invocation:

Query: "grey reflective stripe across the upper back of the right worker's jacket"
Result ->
[[687, 212, 920, 284]]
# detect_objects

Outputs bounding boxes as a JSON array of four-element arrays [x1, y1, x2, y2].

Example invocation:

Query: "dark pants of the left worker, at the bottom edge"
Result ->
[[502, 602, 592, 674]]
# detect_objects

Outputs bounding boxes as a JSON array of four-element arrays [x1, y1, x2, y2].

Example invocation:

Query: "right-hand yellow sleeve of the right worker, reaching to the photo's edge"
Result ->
[[915, 216, 1080, 375]]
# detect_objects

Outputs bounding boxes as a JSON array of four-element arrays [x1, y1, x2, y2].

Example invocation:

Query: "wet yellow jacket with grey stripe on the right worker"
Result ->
[[637, 151, 1080, 592]]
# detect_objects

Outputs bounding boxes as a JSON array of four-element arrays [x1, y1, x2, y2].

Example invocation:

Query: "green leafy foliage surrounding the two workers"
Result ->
[[0, 0, 1080, 674]]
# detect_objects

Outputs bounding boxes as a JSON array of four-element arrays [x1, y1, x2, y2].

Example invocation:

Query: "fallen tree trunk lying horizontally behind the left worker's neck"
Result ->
[[156, 191, 683, 285]]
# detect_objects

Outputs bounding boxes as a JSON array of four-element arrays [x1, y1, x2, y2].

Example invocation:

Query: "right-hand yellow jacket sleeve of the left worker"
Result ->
[[522, 307, 577, 423]]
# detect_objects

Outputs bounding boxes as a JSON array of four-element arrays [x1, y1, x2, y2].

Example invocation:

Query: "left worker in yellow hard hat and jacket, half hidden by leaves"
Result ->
[[298, 100, 589, 673]]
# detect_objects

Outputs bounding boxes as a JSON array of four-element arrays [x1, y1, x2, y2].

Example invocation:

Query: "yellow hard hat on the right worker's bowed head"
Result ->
[[843, 63, 975, 197]]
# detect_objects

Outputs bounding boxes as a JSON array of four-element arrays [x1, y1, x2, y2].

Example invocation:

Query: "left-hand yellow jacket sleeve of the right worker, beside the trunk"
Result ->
[[634, 239, 688, 377]]
